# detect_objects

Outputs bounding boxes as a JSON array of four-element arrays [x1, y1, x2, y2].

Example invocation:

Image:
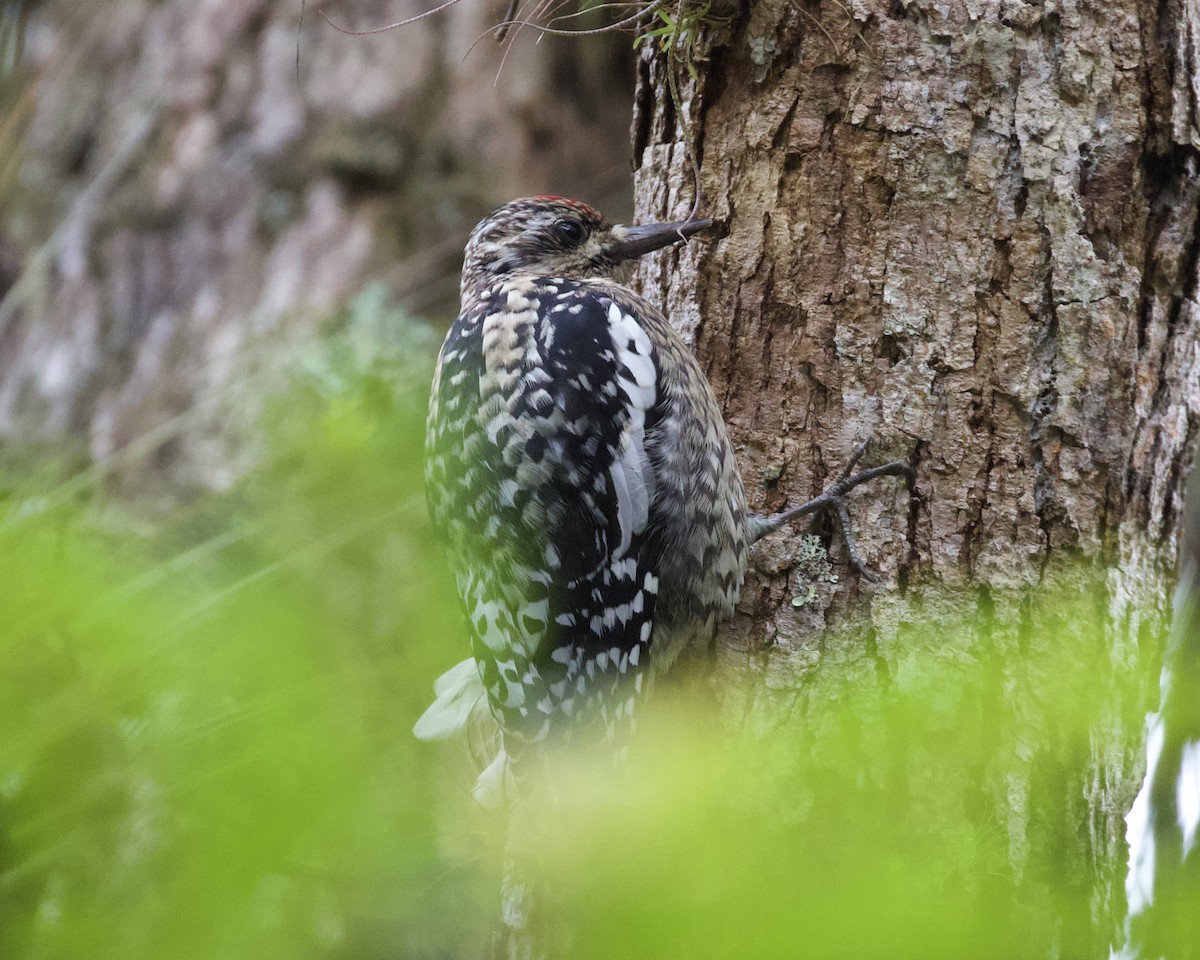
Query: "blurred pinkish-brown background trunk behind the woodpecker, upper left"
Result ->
[[0, 0, 632, 505]]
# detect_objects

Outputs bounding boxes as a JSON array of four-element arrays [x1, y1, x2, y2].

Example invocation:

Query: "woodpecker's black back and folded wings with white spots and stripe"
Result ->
[[431, 280, 661, 739]]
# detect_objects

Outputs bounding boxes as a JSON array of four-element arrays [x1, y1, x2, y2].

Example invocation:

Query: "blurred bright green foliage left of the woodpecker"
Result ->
[[0, 290, 484, 959]]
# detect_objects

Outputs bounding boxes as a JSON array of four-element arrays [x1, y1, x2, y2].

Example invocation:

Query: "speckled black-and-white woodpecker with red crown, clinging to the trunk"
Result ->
[[419, 198, 746, 748]]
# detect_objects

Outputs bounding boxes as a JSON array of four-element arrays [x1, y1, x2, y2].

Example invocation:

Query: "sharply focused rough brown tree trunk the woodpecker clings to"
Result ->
[[632, 0, 1200, 947]]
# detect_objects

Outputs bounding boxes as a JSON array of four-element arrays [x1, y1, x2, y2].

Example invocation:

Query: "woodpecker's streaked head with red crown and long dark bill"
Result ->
[[453, 197, 712, 294]]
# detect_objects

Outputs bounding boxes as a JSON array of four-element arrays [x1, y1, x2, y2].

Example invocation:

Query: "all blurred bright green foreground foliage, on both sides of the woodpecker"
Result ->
[[0, 289, 1176, 960]]
